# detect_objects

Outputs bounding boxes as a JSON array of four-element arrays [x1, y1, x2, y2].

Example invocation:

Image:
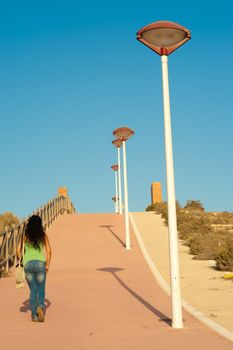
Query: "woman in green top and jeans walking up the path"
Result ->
[[17, 215, 51, 322]]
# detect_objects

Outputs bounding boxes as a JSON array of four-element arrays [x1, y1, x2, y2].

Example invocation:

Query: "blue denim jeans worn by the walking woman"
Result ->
[[24, 260, 46, 318]]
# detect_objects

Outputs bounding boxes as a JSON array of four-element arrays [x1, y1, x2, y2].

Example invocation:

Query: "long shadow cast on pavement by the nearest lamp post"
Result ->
[[97, 267, 172, 327]]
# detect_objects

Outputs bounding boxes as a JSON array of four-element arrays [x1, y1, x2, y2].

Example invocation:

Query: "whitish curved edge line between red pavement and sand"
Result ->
[[129, 213, 233, 342]]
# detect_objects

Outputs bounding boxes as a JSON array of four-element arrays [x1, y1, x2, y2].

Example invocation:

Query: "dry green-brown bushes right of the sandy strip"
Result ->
[[146, 200, 233, 271]]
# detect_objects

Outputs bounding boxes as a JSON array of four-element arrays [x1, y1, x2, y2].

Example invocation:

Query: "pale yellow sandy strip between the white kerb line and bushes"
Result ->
[[133, 212, 233, 332]]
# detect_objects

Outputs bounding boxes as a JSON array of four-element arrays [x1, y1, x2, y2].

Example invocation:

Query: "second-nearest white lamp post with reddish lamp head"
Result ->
[[113, 127, 134, 250]]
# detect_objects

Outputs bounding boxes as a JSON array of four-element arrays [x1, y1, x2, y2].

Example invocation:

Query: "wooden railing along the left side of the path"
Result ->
[[0, 195, 75, 277]]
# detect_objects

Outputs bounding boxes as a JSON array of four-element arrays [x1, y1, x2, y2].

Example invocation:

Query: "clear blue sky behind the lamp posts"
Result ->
[[0, 0, 233, 217]]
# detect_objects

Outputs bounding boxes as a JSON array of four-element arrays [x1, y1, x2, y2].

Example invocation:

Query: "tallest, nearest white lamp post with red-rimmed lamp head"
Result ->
[[137, 21, 191, 328]]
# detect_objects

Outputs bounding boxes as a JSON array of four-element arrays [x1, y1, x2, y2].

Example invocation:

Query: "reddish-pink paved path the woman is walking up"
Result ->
[[0, 214, 233, 350]]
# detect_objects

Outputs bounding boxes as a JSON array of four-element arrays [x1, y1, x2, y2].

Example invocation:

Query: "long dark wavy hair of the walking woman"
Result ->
[[25, 215, 45, 249]]
